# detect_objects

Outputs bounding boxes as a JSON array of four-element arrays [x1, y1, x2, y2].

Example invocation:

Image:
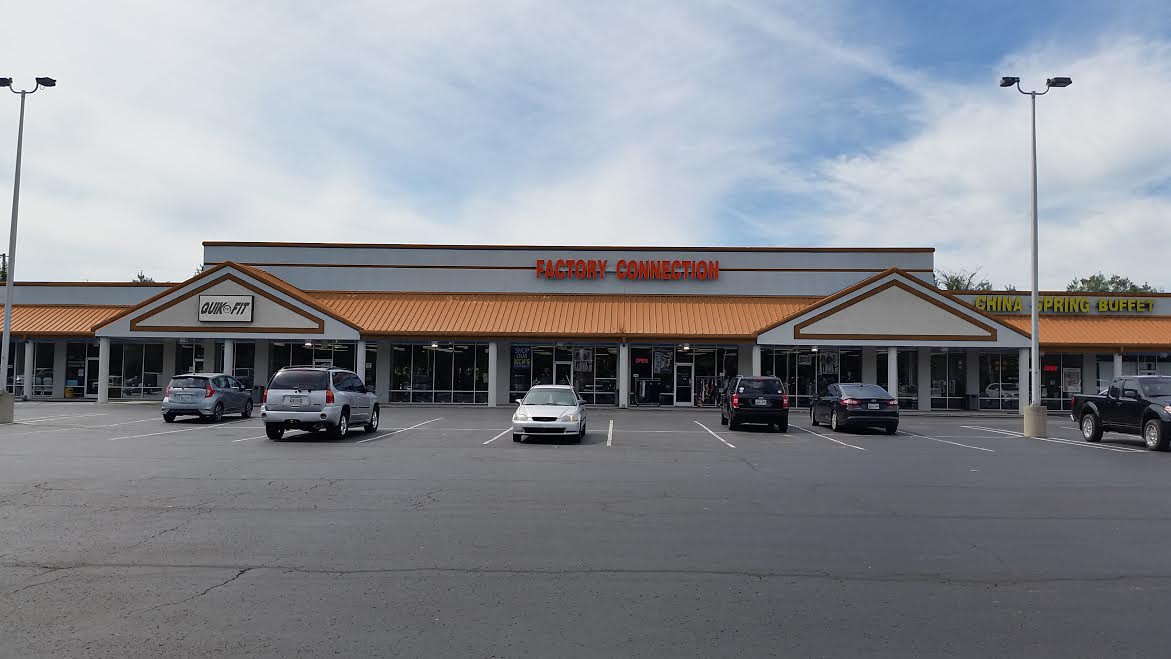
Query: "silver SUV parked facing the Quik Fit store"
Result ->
[[260, 366, 378, 441]]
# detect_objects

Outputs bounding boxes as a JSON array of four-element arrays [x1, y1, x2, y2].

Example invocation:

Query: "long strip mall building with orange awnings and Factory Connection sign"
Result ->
[[7, 242, 1171, 410]]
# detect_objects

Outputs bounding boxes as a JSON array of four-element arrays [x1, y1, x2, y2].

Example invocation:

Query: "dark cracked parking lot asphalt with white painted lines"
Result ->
[[0, 403, 1171, 658]]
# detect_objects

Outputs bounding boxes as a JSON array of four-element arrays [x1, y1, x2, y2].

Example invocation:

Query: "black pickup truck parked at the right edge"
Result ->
[[1070, 376, 1171, 451]]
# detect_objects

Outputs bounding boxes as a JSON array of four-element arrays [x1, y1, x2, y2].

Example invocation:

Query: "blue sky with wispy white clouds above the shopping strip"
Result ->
[[0, 0, 1171, 289]]
